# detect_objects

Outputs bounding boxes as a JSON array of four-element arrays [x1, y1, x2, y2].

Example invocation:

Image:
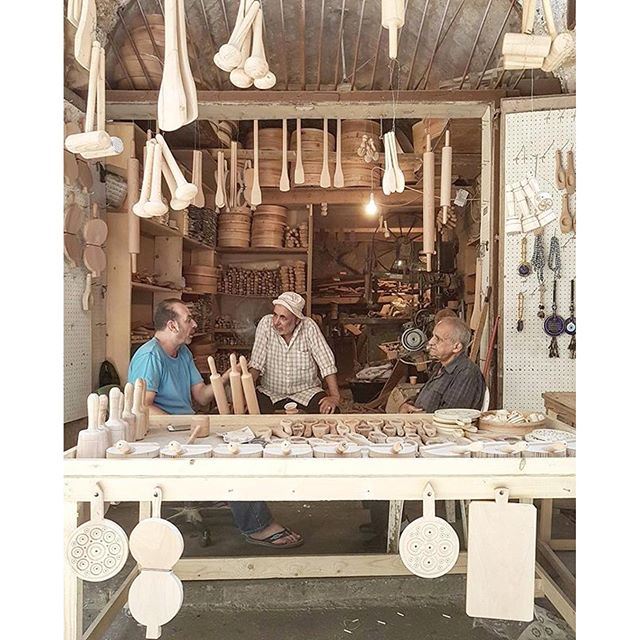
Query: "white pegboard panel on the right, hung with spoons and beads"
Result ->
[[500, 108, 577, 410]]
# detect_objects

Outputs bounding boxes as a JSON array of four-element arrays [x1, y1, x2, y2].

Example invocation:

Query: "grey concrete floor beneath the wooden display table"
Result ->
[[84, 502, 575, 640]]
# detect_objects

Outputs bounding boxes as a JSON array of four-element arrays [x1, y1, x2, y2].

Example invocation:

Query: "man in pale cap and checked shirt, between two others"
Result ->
[[249, 291, 340, 413]]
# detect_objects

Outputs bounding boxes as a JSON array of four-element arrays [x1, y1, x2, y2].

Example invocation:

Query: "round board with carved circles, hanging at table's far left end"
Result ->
[[66, 482, 129, 582]]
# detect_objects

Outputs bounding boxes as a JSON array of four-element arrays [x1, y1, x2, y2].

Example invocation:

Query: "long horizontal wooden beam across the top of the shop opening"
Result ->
[[107, 90, 506, 120]]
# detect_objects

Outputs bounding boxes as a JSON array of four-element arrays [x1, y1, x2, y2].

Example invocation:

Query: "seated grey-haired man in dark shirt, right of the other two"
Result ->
[[400, 317, 486, 413]]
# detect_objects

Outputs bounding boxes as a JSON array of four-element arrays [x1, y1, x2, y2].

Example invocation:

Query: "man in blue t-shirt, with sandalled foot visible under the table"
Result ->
[[128, 298, 303, 549]]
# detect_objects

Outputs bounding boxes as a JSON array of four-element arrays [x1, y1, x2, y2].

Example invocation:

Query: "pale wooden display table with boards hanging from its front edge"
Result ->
[[64, 414, 576, 640]]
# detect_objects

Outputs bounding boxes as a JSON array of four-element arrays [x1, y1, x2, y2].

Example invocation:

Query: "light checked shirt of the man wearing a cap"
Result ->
[[249, 314, 338, 406]]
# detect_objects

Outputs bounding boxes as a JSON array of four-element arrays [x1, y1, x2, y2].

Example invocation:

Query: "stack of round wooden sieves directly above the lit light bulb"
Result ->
[[340, 120, 384, 187]]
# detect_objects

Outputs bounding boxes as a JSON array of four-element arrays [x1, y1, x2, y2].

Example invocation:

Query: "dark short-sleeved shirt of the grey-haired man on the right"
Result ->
[[415, 354, 485, 413]]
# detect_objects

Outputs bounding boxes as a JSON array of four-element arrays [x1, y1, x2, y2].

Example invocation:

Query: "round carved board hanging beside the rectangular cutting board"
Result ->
[[397, 482, 460, 578]]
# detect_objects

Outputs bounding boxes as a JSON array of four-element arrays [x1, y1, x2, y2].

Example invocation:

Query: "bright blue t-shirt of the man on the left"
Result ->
[[128, 338, 204, 415]]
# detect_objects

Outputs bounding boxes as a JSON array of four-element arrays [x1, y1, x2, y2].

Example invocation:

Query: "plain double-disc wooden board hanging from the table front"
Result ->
[[128, 487, 184, 638]]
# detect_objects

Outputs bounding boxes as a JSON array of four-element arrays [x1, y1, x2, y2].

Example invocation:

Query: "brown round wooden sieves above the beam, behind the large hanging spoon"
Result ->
[[110, 13, 208, 89]]
